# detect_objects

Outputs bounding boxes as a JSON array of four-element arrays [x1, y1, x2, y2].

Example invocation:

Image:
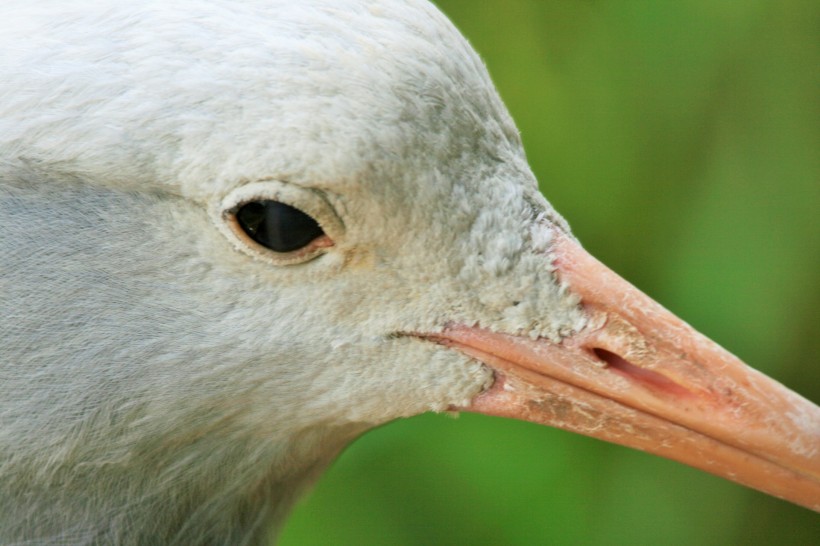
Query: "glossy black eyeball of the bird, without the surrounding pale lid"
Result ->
[[236, 201, 324, 252]]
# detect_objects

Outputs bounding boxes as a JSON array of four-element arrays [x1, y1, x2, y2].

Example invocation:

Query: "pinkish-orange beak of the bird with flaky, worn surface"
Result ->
[[425, 228, 820, 511]]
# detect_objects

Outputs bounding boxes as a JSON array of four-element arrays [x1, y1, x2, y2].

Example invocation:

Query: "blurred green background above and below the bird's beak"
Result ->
[[280, 0, 820, 546]]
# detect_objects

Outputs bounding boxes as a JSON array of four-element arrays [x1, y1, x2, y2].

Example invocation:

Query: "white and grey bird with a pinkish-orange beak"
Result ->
[[0, 0, 820, 544]]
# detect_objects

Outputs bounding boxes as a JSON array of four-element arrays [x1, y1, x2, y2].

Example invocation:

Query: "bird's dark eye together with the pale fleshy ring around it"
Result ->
[[215, 180, 344, 265]]
